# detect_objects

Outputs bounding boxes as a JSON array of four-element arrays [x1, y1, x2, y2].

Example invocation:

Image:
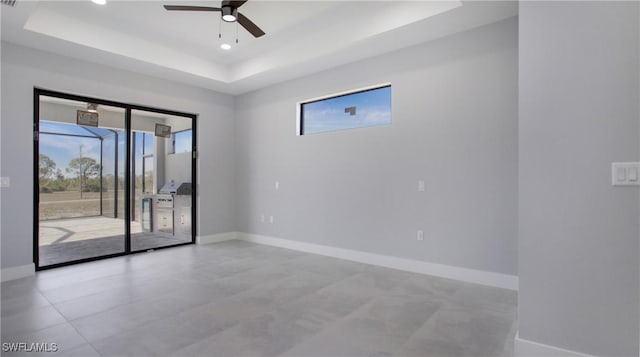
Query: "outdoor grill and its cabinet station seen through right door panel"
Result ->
[[142, 181, 191, 238]]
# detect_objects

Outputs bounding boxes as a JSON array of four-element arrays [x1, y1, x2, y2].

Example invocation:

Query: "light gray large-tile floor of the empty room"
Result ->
[[1, 241, 517, 357]]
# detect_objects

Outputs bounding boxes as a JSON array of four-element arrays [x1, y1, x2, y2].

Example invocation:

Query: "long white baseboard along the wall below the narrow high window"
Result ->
[[237, 232, 518, 290]]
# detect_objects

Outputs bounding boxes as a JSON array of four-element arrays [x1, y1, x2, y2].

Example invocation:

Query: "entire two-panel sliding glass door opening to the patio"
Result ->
[[34, 89, 195, 269]]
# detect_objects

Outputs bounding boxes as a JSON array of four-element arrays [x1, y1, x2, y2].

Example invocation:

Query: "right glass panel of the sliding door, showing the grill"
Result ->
[[131, 110, 193, 251]]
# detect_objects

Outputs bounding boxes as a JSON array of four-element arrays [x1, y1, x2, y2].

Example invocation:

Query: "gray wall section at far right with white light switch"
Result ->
[[518, 2, 640, 356]]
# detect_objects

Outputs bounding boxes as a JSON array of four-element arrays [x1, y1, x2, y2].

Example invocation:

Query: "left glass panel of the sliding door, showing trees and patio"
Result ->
[[36, 95, 126, 267]]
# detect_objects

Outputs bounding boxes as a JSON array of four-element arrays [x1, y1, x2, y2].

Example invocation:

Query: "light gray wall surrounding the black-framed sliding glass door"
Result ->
[[0, 42, 235, 268]]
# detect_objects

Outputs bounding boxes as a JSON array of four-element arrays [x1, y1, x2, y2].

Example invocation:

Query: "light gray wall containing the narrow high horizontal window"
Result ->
[[236, 18, 518, 275]]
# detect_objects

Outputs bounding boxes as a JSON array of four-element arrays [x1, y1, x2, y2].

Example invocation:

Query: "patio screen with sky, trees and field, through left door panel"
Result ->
[[39, 120, 125, 221]]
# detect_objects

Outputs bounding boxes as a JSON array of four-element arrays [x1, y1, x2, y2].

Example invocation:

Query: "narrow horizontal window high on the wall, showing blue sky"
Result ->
[[298, 84, 391, 135]]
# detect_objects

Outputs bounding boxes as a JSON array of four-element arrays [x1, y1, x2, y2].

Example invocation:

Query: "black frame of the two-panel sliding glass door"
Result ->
[[33, 87, 198, 270]]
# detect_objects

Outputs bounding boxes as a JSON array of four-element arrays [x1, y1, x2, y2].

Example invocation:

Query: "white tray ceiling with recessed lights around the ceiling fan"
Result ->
[[0, 0, 517, 94]]
